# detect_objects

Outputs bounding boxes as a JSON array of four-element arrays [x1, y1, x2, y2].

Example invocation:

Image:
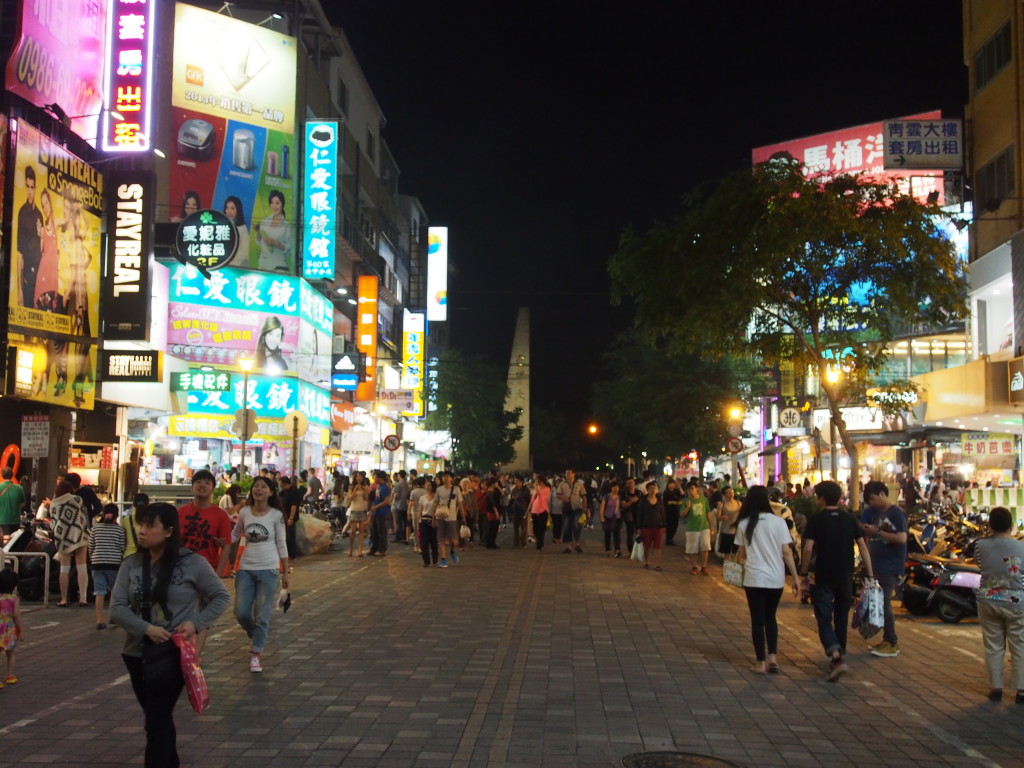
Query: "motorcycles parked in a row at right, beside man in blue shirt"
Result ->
[[896, 500, 988, 624]]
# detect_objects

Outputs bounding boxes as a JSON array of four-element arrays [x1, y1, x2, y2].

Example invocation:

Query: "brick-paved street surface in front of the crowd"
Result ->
[[0, 531, 1024, 768]]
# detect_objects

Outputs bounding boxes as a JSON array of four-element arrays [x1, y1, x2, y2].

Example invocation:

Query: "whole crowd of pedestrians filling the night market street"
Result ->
[[0, 468, 1024, 766]]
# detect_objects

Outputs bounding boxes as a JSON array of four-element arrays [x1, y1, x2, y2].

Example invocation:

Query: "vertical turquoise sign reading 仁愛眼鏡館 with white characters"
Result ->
[[302, 121, 338, 280]]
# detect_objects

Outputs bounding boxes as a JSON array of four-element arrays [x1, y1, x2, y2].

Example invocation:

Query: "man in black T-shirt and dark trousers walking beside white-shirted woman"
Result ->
[[801, 480, 873, 683]]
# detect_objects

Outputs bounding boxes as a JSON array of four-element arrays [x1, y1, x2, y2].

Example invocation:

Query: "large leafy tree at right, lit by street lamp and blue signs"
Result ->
[[609, 159, 966, 512]]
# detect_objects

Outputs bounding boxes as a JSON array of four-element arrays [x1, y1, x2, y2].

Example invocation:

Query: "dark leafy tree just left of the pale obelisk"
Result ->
[[425, 349, 522, 471]]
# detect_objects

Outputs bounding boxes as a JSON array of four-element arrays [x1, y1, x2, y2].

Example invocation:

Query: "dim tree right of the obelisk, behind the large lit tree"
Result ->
[[594, 331, 746, 475]]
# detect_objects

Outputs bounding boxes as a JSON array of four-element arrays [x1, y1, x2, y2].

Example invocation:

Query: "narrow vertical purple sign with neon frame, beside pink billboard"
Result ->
[[102, 0, 156, 152]]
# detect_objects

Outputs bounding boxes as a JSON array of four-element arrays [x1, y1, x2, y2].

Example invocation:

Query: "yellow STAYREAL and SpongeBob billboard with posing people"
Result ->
[[7, 122, 103, 409]]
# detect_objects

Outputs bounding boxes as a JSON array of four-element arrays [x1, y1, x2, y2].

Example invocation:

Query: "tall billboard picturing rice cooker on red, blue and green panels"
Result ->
[[169, 3, 298, 274]]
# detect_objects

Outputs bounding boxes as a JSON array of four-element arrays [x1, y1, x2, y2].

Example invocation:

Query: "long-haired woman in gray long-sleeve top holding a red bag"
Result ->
[[111, 503, 230, 768]]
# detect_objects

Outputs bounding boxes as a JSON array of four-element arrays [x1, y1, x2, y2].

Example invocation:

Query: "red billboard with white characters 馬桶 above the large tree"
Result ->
[[752, 111, 943, 202]]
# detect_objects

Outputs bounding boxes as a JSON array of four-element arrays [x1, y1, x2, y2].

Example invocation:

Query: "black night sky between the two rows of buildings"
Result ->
[[324, 0, 967, 419]]
